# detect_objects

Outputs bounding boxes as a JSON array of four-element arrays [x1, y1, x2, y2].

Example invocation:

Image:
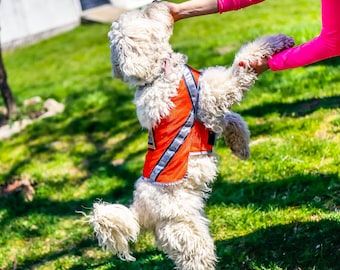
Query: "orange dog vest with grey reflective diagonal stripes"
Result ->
[[142, 66, 215, 185]]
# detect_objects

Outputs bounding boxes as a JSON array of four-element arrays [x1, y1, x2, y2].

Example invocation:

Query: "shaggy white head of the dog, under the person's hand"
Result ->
[[108, 3, 174, 85]]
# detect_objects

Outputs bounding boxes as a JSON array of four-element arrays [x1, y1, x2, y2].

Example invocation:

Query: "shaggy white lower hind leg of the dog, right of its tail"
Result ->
[[155, 215, 217, 270]]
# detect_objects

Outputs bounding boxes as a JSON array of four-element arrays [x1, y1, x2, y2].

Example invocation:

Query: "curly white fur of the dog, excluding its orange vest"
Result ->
[[83, 3, 293, 270]]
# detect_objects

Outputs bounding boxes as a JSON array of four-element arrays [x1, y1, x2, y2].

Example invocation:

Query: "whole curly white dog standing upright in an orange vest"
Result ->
[[87, 3, 294, 270]]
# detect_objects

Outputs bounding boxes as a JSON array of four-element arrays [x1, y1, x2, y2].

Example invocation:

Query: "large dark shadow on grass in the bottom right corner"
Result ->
[[216, 220, 340, 270]]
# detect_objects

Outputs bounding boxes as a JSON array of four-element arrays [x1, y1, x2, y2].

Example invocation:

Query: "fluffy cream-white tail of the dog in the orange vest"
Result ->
[[87, 202, 140, 261]]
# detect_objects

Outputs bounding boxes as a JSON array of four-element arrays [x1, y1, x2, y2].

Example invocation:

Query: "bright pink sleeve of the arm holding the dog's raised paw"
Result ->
[[268, 0, 340, 71]]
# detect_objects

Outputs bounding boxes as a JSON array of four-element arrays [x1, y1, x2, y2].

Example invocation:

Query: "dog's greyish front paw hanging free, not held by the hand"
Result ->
[[223, 113, 250, 160]]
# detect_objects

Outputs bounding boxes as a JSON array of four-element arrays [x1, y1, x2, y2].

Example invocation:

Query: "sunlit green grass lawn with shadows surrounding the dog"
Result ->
[[0, 0, 340, 270]]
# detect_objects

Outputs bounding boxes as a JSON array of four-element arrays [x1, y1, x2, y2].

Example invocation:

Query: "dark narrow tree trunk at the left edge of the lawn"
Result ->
[[0, 0, 16, 119]]
